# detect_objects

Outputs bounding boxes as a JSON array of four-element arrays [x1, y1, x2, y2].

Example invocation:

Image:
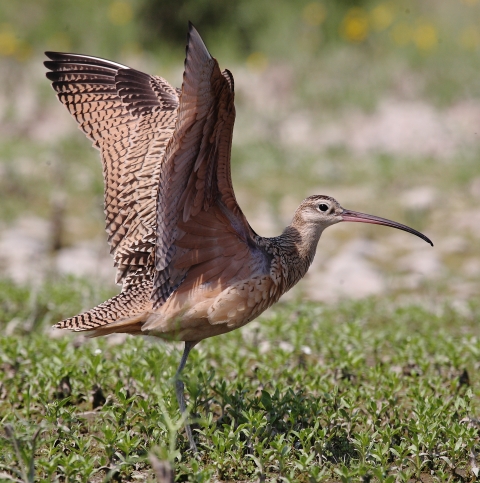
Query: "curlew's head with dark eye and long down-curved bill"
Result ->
[[295, 195, 433, 246]]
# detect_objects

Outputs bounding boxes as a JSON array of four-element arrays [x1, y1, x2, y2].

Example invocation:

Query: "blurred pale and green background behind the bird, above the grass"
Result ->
[[0, 0, 480, 308]]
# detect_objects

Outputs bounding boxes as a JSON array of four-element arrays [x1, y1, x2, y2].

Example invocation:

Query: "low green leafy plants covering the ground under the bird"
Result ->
[[0, 280, 480, 482]]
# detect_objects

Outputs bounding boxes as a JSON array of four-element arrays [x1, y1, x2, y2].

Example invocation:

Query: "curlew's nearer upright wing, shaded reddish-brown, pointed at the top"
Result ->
[[152, 25, 252, 307]]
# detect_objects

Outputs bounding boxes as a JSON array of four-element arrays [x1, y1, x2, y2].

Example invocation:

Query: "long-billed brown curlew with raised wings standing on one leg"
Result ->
[[44, 23, 433, 452]]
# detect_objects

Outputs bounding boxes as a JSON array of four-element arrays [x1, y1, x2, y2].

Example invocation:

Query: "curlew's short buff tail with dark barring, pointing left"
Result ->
[[53, 281, 153, 337]]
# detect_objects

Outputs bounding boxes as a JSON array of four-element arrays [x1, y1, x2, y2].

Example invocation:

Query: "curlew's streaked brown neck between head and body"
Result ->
[[276, 218, 323, 290]]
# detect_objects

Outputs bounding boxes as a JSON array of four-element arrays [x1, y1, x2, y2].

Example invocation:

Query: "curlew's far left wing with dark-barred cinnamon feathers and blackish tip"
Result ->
[[45, 52, 178, 289]]
